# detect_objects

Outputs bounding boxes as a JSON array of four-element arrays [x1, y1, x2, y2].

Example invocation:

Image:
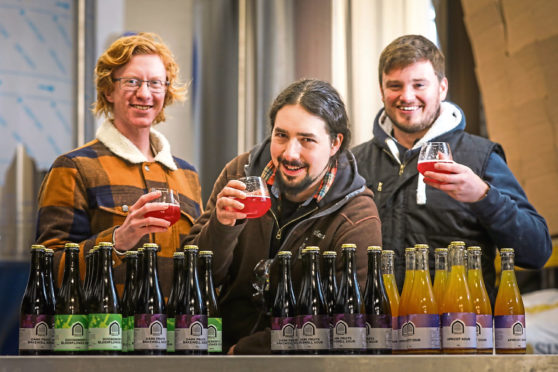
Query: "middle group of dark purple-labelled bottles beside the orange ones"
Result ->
[[271, 244, 392, 354]]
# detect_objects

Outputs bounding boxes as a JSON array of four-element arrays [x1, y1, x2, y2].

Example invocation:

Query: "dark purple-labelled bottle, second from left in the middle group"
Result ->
[[296, 247, 331, 354]]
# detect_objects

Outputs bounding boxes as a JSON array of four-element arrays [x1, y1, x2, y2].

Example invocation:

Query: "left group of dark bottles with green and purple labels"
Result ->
[[19, 243, 222, 355]]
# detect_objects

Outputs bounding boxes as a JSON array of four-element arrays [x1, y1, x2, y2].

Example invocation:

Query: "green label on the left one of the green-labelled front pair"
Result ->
[[54, 314, 87, 351]]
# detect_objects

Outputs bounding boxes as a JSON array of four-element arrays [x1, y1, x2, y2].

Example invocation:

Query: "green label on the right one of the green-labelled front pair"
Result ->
[[88, 314, 122, 351]]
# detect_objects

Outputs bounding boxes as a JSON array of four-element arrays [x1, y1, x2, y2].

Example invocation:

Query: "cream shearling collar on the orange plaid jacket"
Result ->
[[96, 119, 178, 171]]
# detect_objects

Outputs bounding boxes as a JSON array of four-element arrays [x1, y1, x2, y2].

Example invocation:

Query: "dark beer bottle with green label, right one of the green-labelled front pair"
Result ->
[[87, 242, 122, 355]]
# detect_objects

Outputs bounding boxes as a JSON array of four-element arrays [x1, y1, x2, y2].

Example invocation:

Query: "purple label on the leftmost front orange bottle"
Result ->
[[399, 314, 440, 350]]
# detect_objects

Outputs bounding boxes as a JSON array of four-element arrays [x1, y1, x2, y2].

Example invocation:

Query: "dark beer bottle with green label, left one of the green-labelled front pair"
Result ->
[[54, 243, 87, 355]]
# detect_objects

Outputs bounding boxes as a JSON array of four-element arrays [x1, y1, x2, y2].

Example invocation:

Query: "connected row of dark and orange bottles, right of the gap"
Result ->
[[271, 242, 526, 354]]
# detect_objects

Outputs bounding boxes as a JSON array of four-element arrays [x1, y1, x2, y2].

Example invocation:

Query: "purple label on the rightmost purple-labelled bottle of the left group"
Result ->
[[174, 314, 207, 350]]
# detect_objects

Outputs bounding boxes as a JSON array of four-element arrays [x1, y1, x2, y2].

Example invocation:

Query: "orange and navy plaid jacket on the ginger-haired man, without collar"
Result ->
[[36, 122, 201, 296]]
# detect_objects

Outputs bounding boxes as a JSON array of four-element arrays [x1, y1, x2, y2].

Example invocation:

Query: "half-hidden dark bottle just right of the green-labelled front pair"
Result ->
[[121, 251, 138, 353]]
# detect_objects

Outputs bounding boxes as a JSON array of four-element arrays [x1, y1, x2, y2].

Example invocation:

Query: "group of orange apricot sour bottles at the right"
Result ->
[[394, 242, 526, 354]]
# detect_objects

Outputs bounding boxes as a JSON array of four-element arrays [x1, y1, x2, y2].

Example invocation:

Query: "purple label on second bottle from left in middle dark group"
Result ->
[[296, 315, 331, 350]]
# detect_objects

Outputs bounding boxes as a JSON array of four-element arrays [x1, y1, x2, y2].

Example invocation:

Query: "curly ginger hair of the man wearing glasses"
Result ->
[[92, 32, 186, 124]]
